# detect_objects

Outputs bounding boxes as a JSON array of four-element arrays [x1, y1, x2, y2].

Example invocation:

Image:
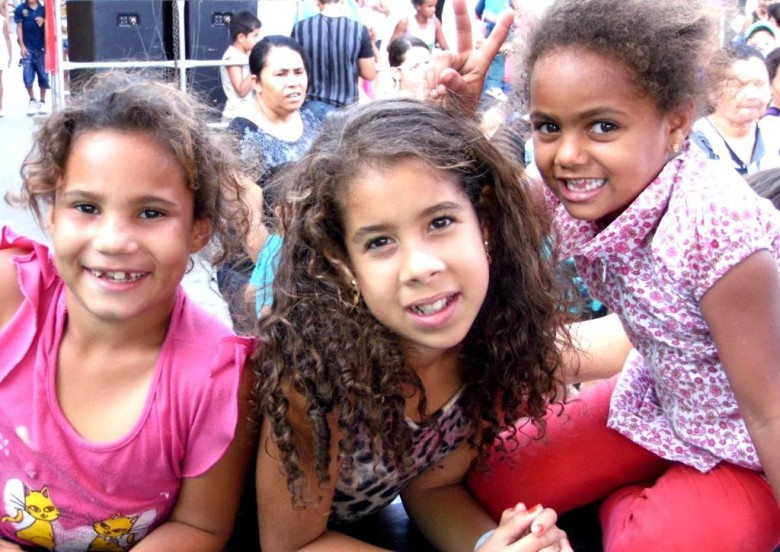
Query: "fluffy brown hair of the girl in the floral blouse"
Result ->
[[517, 0, 717, 114]]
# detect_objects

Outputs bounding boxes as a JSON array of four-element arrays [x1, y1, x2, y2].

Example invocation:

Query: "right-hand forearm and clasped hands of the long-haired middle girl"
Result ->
[[402, 444, 571, 552]]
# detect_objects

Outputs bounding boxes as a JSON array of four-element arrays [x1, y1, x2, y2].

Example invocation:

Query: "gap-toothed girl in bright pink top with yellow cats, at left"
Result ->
[[0, 75, 253, 552]]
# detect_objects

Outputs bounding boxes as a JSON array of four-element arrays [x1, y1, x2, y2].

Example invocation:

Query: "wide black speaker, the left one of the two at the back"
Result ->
[[66, 0, 172, 61]]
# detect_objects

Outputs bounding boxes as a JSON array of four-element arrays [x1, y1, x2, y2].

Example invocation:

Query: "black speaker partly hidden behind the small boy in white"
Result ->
[[185, 0, 257, 111]]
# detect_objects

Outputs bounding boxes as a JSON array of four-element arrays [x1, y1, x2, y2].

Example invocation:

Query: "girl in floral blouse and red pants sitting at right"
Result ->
[[452, 0, 780, 552]]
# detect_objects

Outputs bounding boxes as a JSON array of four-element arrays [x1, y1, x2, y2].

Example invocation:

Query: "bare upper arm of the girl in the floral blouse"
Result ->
[[701, 251, 780, 503]]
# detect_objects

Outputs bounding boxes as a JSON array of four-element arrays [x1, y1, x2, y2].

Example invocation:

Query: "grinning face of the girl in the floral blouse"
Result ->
[[531, 48, 687, 224]]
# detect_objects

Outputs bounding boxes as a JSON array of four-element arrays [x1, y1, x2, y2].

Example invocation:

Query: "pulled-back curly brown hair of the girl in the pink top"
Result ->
[[12, 72, 250, 263]]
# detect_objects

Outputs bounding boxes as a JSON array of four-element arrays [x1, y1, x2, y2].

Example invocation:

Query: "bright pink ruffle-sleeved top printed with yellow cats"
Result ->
[[0, 228, 252, 550]]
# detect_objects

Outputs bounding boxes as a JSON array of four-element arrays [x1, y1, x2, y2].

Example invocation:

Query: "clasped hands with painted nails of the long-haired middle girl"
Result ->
[[476, 503, 573, 552]]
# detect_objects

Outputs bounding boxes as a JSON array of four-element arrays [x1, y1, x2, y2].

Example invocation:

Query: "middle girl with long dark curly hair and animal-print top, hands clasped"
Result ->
[[254, 99, 571, 552]]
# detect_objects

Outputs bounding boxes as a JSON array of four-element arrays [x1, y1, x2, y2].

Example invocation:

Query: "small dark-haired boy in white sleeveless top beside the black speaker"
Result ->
[[219, 11, 261, 121]]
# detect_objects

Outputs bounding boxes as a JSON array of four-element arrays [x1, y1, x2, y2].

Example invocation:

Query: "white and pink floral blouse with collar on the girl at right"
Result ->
[[547, 145, 780, 471]]
